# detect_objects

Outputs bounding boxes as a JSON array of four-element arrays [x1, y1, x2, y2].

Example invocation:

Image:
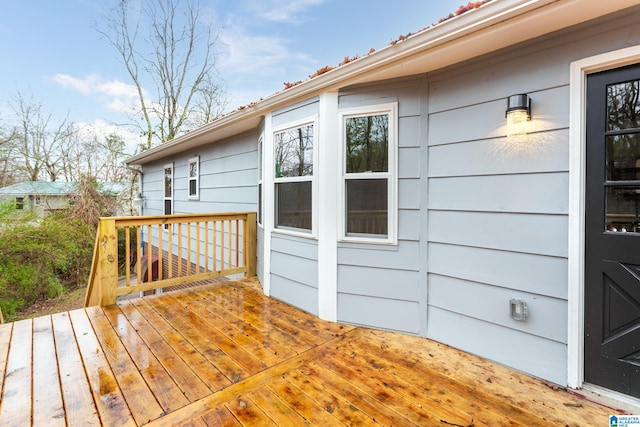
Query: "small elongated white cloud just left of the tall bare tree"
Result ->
[[53, 74, 139, 113]]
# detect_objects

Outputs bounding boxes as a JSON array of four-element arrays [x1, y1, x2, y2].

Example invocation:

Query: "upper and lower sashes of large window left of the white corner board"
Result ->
[[273, 120, 314, 232]]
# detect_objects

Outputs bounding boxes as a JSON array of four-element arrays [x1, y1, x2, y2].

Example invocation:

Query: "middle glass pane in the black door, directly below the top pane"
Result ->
[[606, 133, 640, 181]]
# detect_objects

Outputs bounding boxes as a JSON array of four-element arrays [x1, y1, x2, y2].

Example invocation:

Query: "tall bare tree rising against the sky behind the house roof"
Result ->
[[98, 0, 223, 148]]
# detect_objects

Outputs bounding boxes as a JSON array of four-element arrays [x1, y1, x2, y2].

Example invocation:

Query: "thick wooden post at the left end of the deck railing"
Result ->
[[96, 218, 118, 306]]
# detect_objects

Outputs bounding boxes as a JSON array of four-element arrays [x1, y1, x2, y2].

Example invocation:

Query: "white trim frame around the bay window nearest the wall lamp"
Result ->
[[338, 102, 398, 245]]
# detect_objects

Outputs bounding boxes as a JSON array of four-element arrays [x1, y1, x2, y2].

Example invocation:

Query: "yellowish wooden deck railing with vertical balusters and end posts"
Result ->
[[85, 212, 256, 307]]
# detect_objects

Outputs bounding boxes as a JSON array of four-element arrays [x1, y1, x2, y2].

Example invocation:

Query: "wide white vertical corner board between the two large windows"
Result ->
[[314, 92, 340, 322]]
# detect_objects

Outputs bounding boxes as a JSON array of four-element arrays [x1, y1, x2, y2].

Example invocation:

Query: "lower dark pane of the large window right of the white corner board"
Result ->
[[345, 179, 388, 236]]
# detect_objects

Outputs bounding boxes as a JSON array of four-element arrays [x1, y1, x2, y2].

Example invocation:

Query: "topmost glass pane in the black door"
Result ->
[[607, 80, 640, 131]]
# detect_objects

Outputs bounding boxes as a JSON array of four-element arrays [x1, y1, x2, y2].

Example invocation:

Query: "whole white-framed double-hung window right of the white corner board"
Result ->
[[341, 104, 397, 243]]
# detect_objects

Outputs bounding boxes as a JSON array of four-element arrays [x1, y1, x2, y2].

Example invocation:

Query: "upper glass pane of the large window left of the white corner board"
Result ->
[[274, 125, 313, 178]]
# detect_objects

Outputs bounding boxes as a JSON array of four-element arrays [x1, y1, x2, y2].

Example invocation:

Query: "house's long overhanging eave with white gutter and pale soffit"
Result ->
[[126, 0, 638, 165]]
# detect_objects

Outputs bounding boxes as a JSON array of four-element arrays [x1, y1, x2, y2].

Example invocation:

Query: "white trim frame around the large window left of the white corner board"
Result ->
[[272, 116, 320, 239]]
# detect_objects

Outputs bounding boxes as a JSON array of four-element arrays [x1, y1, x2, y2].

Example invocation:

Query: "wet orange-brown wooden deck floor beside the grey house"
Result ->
[[0, 280, 615, 426]]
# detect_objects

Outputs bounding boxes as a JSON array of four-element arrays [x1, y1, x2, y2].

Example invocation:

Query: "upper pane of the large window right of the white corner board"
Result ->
[[345, 114, 389, 173]]
